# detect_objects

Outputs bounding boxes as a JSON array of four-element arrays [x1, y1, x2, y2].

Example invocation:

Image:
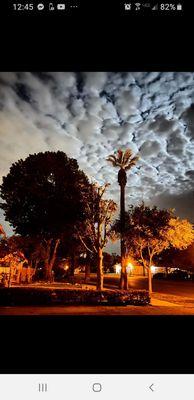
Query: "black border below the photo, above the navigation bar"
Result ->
[[0, 316, 194, 374]]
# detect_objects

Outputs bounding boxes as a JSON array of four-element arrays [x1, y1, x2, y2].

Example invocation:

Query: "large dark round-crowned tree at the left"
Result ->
[[0, 151, 90, 280]]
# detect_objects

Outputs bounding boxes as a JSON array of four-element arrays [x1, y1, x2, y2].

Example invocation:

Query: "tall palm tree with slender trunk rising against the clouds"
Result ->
[[107, 149, 139, 290]]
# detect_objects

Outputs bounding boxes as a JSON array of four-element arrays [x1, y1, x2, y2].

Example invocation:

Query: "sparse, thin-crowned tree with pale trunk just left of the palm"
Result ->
[[78, 184, 117, 290]]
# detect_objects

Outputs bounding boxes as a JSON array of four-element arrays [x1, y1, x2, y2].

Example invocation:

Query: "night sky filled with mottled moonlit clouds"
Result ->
[[0, 72, 194, 252]]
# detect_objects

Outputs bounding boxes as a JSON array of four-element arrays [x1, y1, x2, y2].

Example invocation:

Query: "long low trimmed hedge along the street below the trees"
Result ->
[[0, 287, 150, 306]]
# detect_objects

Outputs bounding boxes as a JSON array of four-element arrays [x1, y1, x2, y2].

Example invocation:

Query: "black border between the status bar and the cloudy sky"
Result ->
[[0, 8, 194, 71]]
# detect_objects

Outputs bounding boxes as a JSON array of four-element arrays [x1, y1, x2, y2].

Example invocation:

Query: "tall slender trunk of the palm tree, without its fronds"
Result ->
[[119, 177, 128, 290]]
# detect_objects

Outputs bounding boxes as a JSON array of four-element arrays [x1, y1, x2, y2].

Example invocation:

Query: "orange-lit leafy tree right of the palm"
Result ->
[[111, 204, 194, 295]]
